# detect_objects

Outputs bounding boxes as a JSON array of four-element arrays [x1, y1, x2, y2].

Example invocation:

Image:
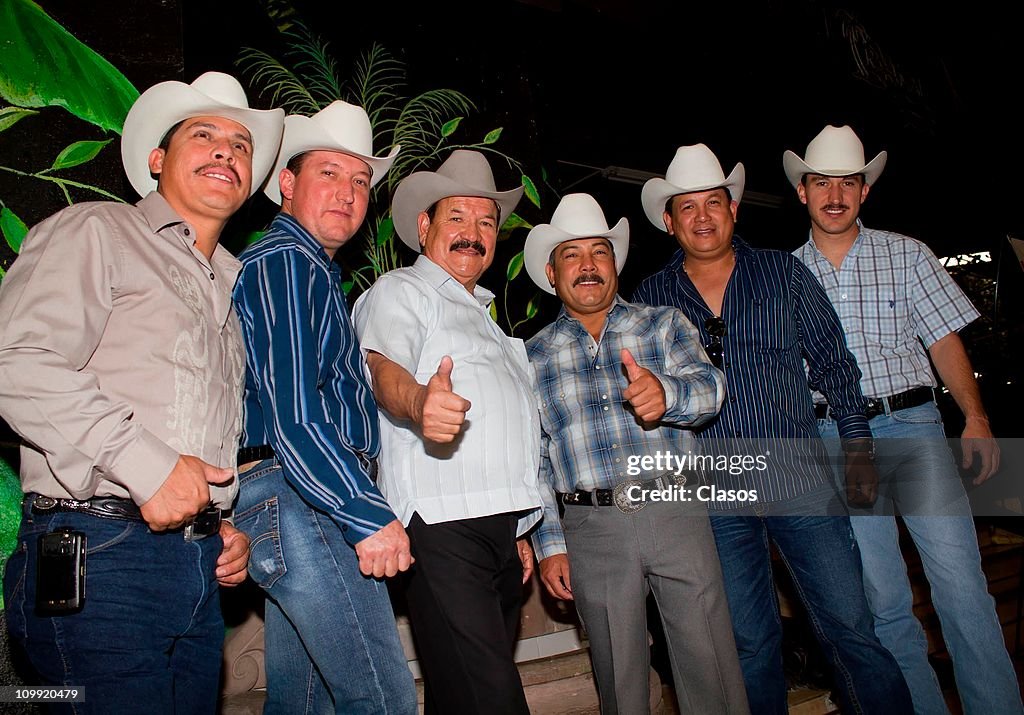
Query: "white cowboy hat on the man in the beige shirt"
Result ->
[[121, 72, 285, 196]]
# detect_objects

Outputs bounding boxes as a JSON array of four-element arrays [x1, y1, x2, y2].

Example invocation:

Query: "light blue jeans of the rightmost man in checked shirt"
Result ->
[[818, 403, 1024, 715]]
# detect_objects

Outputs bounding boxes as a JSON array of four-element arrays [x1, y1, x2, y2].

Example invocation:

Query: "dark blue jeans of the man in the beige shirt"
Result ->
[[4, 501, 224, 715]]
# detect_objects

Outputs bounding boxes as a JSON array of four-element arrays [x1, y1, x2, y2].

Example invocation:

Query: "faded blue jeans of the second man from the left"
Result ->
[[234, 459, 417, 715]]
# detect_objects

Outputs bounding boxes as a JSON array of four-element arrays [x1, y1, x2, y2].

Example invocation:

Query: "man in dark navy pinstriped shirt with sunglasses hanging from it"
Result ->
[[634, 144, 910, 713]]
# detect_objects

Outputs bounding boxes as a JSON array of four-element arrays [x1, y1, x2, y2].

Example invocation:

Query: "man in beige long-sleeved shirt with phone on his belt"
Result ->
[[0, 73, 284, 713]]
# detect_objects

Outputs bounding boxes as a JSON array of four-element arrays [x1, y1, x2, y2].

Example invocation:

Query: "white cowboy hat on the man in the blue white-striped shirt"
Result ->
[[263, 99, 401, 204]]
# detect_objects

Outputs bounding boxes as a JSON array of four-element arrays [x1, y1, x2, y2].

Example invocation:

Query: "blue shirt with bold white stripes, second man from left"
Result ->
[[233, 213, 395, 544]]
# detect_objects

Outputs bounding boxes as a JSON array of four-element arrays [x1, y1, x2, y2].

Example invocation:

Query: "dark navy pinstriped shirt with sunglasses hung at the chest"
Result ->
[[633, 237, 871, 497]]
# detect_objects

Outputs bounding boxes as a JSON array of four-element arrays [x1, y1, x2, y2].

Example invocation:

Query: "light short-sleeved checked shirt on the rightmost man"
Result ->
[[794, 222, 979, 402]]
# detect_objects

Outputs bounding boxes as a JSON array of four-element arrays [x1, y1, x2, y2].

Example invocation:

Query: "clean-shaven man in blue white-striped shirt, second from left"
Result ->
[[234, 100, 416, 715]]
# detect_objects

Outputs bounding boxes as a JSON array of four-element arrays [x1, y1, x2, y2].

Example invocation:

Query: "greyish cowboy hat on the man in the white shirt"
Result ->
[[391, 149, 523, 252]]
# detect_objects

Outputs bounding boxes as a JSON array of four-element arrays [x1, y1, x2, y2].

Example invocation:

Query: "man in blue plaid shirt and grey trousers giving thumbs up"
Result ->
[[524, 194, 749, 714]]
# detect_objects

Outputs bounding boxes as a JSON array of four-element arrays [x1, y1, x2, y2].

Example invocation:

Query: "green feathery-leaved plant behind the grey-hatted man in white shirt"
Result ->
[[237, 22, 541, 332]]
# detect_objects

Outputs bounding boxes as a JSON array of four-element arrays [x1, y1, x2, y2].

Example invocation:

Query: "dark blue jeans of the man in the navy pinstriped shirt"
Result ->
[[711, 488, 910, 715]]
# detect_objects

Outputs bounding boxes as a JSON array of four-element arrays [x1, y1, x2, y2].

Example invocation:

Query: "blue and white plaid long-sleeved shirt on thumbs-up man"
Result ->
[[526, 296, 725, 559]]
